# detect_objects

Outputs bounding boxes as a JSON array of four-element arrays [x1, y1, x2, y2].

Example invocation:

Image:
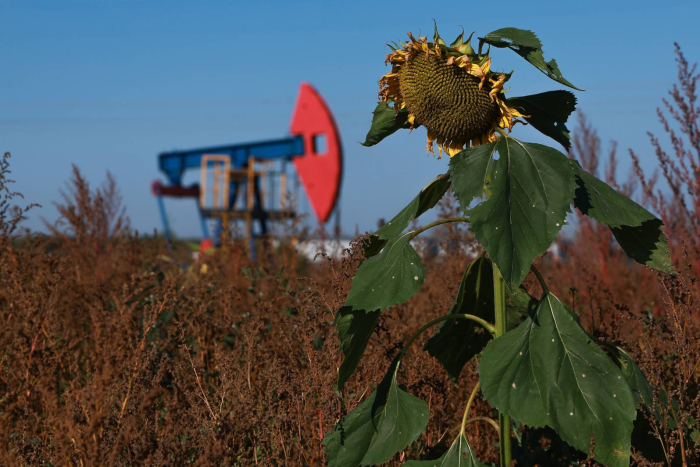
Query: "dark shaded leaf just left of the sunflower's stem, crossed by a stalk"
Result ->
[[424, 256, 494, 384]]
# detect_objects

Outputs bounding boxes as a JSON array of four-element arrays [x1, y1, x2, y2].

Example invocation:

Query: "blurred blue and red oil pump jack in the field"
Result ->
[[151, 83, 343, 249]]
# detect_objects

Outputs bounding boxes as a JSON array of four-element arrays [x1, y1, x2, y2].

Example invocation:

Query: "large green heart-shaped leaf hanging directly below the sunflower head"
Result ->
[[450, 137, 576, 289]]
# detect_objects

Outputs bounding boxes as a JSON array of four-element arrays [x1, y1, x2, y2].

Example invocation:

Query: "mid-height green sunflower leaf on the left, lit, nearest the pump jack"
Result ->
[[345, 236, 425, 311]]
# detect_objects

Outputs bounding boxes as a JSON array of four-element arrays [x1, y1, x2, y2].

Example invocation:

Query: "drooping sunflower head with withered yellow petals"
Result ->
[[379, 30, 527, 158]]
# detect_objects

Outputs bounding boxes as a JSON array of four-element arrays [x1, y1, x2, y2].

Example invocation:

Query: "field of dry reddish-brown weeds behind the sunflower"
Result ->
[[0, 49, 700, 466]]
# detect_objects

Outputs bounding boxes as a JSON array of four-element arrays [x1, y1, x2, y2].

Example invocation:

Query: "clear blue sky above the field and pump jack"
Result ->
[[0, 0, 700, 236]]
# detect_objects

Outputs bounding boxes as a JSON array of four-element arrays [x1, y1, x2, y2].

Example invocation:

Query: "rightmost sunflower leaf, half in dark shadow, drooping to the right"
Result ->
[[571, 161, 675, 274]]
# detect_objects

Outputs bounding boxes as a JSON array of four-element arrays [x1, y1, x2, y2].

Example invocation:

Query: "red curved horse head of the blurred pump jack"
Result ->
[[291, 83, 343, 223]]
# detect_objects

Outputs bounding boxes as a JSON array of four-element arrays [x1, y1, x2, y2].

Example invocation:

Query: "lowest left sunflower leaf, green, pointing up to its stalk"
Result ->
[[323, 359, 429, 467]]
